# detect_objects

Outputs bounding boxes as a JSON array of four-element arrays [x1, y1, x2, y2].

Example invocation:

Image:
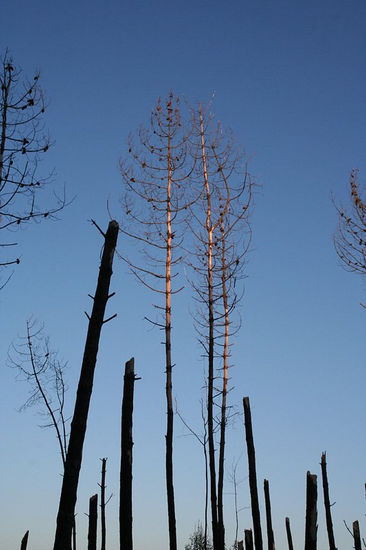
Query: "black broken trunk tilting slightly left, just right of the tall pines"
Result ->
[[243, 397, 263, 550]]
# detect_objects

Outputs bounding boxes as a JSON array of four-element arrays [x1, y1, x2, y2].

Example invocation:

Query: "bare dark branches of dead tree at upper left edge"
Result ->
[[0, 52, 65, 280]]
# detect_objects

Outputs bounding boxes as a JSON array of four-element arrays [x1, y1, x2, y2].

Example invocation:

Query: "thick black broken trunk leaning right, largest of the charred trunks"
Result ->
[[53, 221, 118, 550]]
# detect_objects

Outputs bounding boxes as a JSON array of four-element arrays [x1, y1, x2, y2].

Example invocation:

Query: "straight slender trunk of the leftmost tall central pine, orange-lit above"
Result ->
[[165, 100, 177, 550]]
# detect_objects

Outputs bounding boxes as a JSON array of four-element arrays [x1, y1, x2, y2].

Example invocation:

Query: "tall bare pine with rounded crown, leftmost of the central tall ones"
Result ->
[[121, 93, 192, 550]]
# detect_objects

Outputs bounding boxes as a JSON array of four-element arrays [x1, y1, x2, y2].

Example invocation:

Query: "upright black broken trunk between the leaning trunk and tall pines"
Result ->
[[119, 357, 136, 550]]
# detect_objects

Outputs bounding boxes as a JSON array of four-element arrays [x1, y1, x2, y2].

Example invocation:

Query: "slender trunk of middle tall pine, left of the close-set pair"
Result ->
[[199, 106, 223, 550]]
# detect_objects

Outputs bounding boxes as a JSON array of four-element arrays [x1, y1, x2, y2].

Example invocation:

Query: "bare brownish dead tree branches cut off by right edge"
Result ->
[[334, 170, 366, 302]]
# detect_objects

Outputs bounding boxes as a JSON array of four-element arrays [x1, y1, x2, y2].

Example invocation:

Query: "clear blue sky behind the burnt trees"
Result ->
[[0, 0, 366, 550]]
